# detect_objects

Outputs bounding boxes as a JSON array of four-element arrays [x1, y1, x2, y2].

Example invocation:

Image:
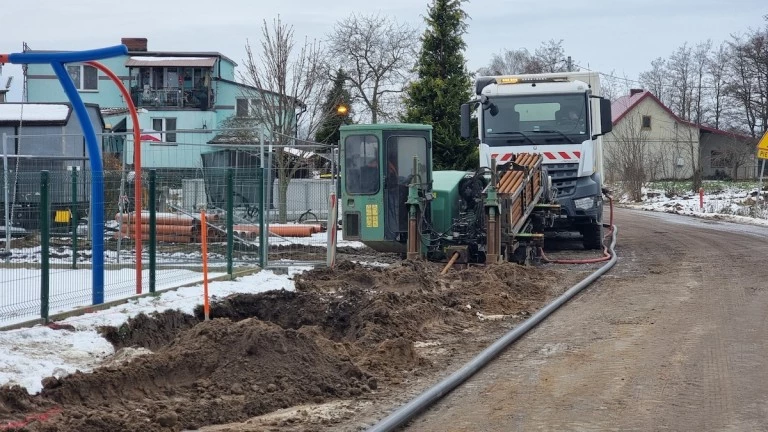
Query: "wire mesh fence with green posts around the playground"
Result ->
[[0, 130, 337, 327]]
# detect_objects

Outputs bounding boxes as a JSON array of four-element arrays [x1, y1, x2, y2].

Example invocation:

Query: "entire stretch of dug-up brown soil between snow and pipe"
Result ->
[[0, 262, 553, 432]]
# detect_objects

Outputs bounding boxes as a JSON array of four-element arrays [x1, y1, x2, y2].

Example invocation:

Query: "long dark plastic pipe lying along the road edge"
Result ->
[[368, 226, 618, 432]]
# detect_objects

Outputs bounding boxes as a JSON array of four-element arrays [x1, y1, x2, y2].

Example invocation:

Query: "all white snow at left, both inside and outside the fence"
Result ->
[[0, 232, 368, 394]]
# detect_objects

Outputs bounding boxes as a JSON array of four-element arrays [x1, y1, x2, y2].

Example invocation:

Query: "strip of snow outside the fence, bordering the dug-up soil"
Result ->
[[0, 267, 307, 394]]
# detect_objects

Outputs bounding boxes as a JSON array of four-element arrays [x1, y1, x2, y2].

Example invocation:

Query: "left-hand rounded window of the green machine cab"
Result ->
[[344, 135, 381, 195]]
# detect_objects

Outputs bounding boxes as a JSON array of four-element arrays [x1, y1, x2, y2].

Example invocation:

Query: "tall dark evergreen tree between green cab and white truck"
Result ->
[[402, 0, 477, 169]]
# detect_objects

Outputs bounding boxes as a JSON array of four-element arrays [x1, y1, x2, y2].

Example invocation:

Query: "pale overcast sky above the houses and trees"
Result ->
[[0, 0, 768, 101]]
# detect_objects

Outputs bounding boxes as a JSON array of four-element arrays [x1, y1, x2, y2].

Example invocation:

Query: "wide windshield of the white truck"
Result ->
[[483, 93, 589, 147]]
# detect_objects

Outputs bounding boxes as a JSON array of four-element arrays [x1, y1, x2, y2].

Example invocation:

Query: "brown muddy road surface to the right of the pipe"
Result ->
[[406, 210, 768, 431]]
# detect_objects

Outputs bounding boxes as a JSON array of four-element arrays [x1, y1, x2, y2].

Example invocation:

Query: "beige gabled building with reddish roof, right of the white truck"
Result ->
[[603, 89, 757, 181]]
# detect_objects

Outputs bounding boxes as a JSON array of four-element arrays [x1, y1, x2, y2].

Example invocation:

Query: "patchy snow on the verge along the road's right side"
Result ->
[[619, 181, 768, 226]]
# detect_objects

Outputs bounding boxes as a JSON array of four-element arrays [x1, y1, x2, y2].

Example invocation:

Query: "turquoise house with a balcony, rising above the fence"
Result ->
[[25, 38, 288, 170]]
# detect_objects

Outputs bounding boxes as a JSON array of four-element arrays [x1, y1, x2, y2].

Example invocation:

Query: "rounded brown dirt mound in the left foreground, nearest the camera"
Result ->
[[13, 319, 370, 431]]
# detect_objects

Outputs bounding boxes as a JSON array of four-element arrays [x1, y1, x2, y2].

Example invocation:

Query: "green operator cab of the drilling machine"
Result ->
[[339, 123, 432, 253]]
